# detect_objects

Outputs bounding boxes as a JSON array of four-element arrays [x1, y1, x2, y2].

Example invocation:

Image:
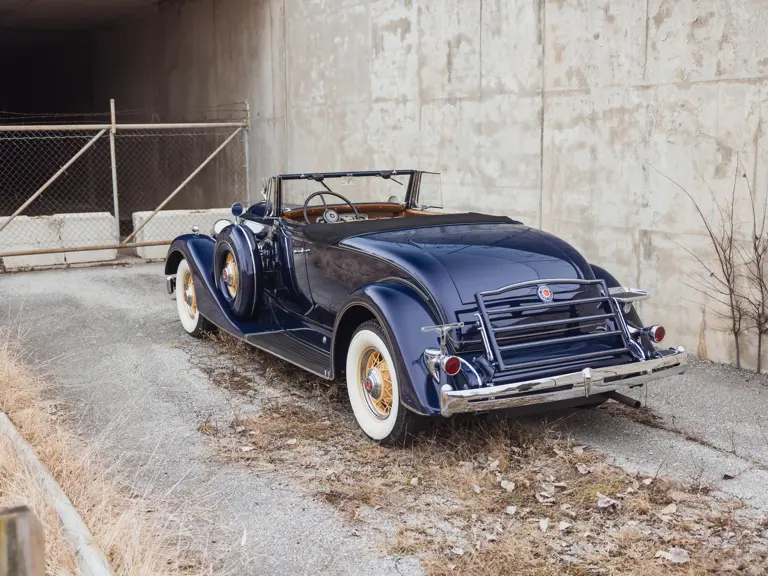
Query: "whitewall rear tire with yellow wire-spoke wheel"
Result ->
[[346, 320, 423, 446]]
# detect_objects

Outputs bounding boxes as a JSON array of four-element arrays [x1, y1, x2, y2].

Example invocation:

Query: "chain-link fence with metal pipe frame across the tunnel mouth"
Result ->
[[0, 102, 250, 269]]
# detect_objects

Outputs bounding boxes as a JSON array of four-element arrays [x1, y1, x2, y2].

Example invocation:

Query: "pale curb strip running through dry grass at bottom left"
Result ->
[[0, 411, 112, 576]]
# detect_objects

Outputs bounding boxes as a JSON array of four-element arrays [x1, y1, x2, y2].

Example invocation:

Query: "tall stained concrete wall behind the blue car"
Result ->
[[97, 0, 768, 363]]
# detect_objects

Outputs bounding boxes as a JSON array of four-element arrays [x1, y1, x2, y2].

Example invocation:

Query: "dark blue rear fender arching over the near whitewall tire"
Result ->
[[332, 280, 440, 416]]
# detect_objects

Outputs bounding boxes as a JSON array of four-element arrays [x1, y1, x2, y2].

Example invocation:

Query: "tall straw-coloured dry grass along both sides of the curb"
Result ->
[[0, 340, 210, 575]]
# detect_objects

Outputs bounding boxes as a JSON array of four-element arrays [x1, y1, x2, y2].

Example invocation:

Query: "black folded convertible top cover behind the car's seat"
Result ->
[[304, 212, 520, 244]]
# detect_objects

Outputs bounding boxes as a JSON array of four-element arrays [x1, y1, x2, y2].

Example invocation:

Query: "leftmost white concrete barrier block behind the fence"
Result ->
[[0, 216, 66, 270]]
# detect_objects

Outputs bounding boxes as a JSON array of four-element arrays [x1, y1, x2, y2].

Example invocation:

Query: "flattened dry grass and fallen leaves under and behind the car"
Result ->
[[200, 338, 768, 576]]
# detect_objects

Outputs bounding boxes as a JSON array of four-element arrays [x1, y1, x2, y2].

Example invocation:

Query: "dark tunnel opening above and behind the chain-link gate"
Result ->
[[0, 14, 246, 236]]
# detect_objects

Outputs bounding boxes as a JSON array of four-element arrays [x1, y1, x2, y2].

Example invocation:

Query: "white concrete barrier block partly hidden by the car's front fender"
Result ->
[[133, 208, 233, 260]]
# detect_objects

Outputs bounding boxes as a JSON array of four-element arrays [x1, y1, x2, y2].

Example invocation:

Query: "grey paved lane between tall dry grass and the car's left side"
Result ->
[[0, 264, 421, 576]]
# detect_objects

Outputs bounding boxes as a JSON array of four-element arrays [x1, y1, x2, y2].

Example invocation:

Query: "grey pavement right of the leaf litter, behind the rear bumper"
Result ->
[[565, 361, 768, 514]]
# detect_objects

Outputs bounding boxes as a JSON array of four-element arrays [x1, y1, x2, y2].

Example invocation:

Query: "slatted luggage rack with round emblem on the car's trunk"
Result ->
[[475, 278, 637, 374]]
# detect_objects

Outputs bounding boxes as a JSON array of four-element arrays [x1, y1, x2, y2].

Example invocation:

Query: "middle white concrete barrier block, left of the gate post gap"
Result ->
[[54, 212, 117, 264]]
